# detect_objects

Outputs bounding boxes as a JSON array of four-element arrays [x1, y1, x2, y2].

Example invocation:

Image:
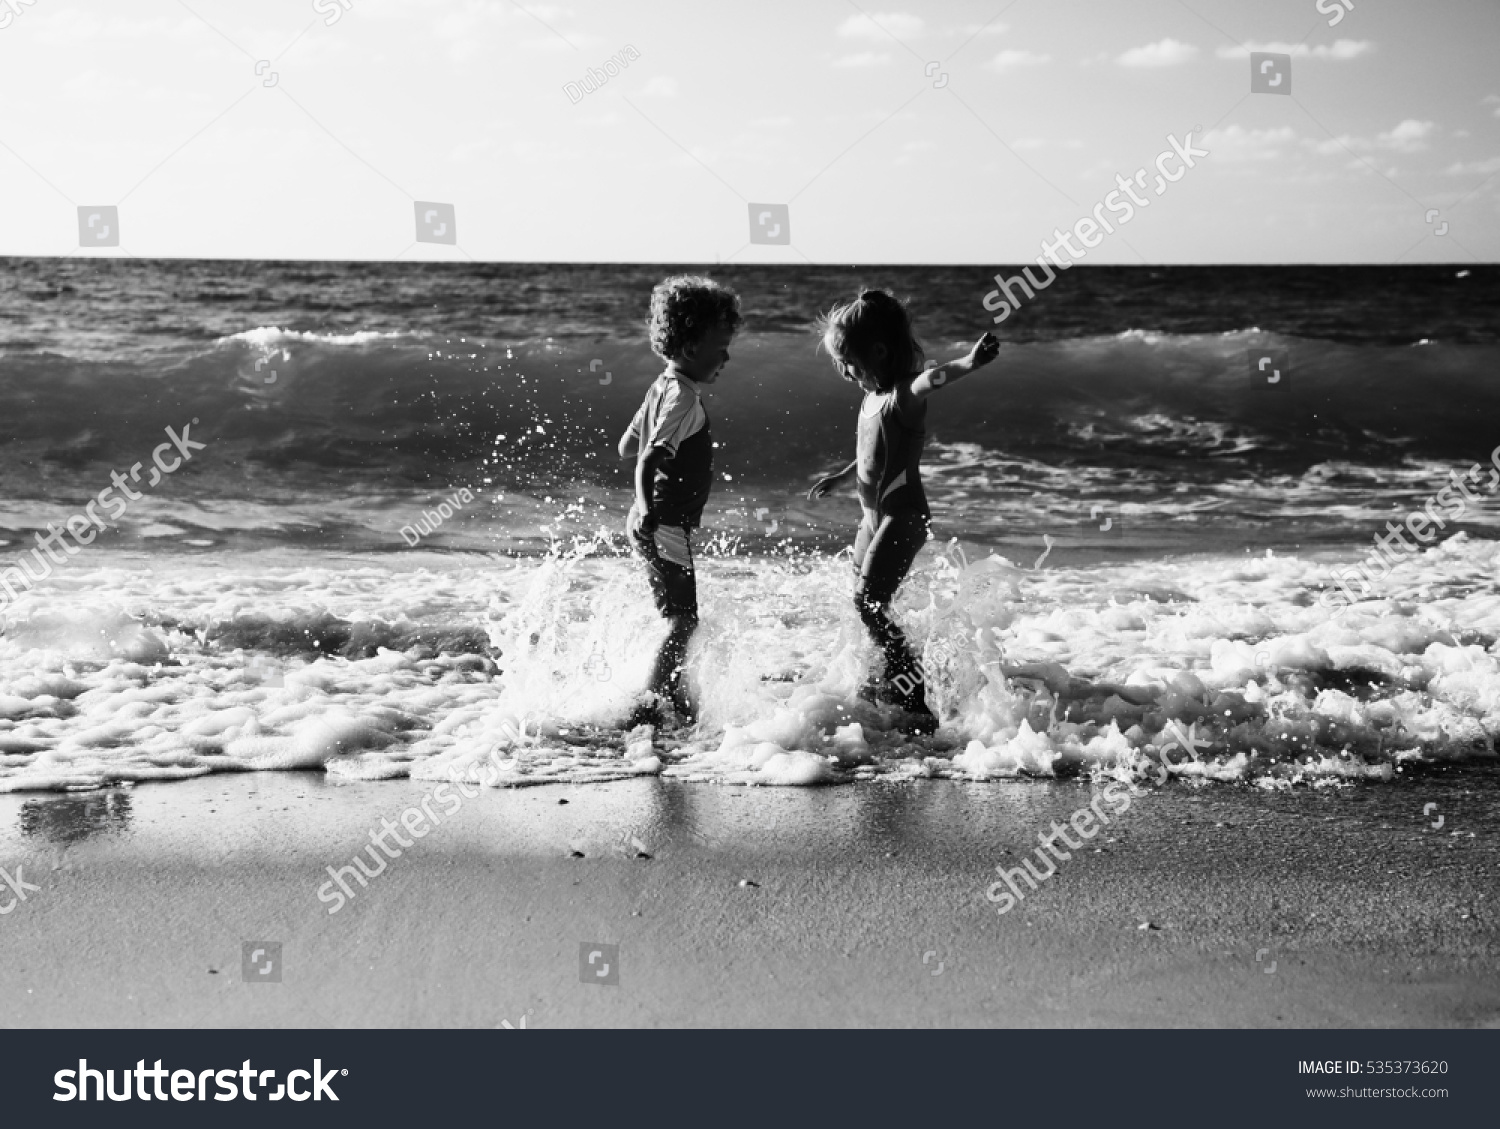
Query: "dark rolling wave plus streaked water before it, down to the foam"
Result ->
[[0, 325, 1500, 552]]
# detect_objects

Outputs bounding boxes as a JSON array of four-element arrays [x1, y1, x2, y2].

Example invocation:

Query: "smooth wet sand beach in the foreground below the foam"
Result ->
[[0, 768, 1500, 1029]]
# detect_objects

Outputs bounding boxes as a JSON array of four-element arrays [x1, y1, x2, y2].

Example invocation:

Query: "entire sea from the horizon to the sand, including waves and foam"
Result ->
[[0, 258, 1500, 792]]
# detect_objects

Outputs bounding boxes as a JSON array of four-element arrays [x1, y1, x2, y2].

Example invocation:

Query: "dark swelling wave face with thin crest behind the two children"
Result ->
[[0, 327, 1500, 463]]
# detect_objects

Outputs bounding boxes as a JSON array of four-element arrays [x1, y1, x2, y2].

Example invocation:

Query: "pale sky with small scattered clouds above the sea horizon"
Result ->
[[0, 0, 1500, 264]]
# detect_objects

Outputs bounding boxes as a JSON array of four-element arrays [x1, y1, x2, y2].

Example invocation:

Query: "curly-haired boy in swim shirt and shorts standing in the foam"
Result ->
[[620, 274, 743, 726]]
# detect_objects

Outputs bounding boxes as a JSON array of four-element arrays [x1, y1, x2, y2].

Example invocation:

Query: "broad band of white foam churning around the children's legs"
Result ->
[[0, 537, 1500, 790]]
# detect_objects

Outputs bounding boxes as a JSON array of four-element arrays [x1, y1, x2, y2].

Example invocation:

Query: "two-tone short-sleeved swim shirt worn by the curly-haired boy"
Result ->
[[629, 370, 714, 529]]
